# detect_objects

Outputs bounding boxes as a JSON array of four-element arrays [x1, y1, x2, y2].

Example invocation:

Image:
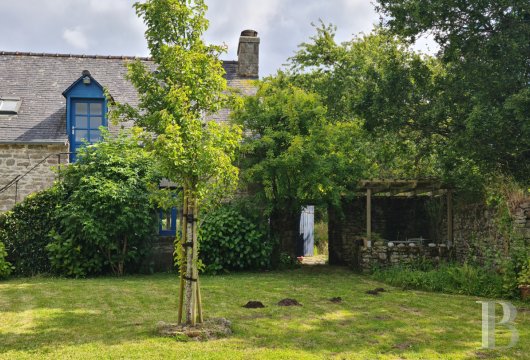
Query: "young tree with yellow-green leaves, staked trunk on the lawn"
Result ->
[[113, 0, 241, 325]]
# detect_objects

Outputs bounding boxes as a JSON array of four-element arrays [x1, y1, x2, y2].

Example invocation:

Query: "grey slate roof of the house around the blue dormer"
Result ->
[[0, 52, 255, 143]]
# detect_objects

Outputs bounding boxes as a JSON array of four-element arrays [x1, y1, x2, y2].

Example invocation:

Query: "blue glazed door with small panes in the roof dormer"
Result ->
[[70, 99, 106, 161]]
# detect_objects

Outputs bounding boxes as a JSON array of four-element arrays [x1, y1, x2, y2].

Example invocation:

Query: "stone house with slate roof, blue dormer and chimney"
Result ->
[[0, 30, 260, 217]]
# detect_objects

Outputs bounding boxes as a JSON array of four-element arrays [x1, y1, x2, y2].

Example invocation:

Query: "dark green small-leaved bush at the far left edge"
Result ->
[[0, 187, 64, 276]]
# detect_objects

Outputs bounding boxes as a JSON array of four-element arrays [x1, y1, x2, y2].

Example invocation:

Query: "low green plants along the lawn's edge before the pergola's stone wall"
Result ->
[[373, 264, 506, 298]]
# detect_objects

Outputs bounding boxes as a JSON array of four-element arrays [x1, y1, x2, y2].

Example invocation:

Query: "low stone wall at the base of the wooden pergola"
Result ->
[[361, 241, 450, 271]]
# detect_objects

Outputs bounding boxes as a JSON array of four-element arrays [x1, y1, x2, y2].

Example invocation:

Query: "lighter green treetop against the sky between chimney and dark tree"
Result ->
[[290, 24, 440, 132]]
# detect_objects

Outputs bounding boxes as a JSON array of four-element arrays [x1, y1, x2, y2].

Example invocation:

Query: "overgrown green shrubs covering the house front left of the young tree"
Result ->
[[0, 132, 160, 277]]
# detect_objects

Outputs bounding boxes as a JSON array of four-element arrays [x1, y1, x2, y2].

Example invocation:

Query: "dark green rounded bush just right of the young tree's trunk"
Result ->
[[199, 206, 272, 273]]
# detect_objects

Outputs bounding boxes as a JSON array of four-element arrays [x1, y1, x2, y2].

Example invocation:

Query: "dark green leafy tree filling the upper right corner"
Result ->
[[378, 0, 530, 182]]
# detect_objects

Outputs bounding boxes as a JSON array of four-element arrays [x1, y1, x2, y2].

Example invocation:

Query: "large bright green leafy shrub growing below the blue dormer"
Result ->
[[46, 129, 159, 277]]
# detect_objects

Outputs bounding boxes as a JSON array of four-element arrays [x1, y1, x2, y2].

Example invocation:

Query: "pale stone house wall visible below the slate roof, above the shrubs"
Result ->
[[0, 144, 68, 211]]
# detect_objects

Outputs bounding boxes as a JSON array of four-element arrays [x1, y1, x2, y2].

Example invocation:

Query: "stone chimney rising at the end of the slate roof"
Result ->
[[237, 30, 259, 79]]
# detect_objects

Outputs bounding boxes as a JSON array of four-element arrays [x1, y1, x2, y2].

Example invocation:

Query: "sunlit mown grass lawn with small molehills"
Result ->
[[0, 267, 530, 359]]
